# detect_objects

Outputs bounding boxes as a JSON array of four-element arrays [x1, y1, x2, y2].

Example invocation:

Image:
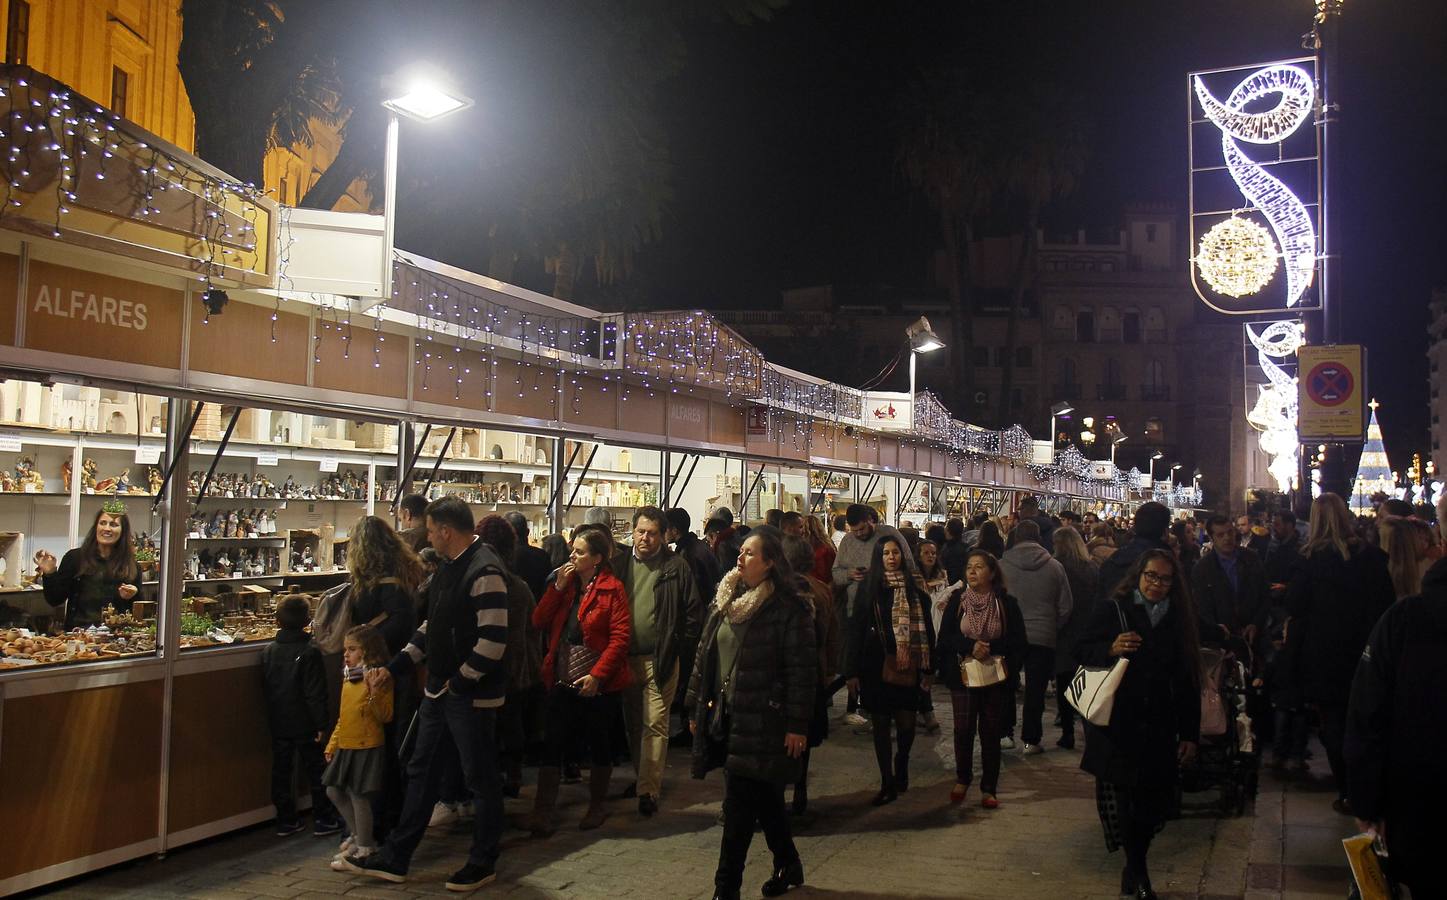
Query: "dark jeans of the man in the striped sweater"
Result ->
[[385, 692, 502, 873]]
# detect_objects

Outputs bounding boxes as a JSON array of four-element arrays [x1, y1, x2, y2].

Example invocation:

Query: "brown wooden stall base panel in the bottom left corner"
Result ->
[[0, 680, 164, 878]]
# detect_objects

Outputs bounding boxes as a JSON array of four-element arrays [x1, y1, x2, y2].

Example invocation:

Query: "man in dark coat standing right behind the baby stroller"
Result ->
[[1191, 515, 1269, 644]]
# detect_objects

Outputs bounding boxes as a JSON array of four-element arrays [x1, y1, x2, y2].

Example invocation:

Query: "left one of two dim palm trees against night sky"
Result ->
[[896, 67, 1000, 412]]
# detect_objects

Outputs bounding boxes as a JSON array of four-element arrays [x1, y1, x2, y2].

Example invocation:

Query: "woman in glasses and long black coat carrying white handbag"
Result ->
[[1075, 550, 1201, 899]]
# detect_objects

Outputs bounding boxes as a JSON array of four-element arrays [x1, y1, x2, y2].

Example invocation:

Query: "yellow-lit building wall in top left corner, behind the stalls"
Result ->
[[0, 0, 368, 211]]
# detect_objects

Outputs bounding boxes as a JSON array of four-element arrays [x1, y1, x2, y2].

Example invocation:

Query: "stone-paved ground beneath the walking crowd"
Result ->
[[36, 690, 1351, 900]]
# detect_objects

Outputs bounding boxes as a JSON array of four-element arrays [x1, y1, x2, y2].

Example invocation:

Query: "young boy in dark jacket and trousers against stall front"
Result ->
[[262, 596, 341, 838]]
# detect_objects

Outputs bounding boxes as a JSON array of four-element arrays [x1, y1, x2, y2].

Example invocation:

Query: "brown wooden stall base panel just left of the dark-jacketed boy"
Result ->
[[168, 663, 271, 833]]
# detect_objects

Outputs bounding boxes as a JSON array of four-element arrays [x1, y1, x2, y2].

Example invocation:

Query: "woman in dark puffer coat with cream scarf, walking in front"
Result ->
[[687, 534, 819, 899]]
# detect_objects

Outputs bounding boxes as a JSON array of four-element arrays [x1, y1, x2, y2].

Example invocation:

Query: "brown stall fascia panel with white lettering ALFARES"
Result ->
[[25, 262, 185, 369]]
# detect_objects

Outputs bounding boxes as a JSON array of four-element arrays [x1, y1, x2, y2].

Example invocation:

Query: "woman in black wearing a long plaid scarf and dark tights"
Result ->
[[846, 534, 935, 806]]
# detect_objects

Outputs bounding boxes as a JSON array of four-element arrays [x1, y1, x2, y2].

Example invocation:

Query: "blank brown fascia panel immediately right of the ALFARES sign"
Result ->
[[187, 302, 308, 385]]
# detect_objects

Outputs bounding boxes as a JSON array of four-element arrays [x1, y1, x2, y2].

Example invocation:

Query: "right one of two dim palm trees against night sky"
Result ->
[[996, 82, 1085, 427]]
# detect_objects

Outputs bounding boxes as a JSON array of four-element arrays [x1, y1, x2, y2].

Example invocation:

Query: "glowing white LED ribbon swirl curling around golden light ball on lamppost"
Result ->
[[1194, 65, 1317, 307]]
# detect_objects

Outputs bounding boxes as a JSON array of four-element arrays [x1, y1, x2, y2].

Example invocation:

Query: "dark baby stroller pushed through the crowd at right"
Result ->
[[1181, 641, 1259, 816]]
